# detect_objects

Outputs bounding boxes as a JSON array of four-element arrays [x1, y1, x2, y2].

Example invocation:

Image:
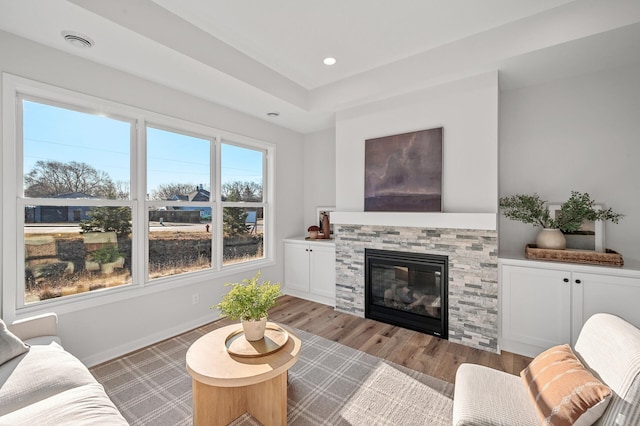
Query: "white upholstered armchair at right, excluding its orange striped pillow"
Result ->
[[453, 314, 640, 426]]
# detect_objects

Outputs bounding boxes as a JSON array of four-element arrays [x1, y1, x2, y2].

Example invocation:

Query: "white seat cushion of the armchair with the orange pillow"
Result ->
[[453, 364, 540, 426]]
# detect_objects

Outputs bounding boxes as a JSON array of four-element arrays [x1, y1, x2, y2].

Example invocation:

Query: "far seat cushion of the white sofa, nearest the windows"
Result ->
[[0, 343, 96, 416]]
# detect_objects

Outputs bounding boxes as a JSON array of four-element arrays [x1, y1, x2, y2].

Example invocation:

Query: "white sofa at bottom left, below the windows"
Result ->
[[0, 314, 128, 426]]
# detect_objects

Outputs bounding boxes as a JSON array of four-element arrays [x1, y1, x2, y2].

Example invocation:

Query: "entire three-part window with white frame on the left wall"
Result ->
[[3, 76, 274, 313]]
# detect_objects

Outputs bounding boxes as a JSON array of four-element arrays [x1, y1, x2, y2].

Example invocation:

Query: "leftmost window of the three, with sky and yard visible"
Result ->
[[18, 97, 134, 305]]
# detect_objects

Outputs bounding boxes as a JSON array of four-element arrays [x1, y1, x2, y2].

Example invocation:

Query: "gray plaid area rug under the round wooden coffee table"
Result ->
[[91, 329, 453, 426]]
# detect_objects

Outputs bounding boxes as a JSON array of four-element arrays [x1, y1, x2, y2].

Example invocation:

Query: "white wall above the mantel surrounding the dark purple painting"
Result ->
[[336, 72, 498, 213]]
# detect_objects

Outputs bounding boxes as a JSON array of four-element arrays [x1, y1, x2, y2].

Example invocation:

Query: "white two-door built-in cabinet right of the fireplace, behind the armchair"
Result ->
[[499, 259, 640, 357]]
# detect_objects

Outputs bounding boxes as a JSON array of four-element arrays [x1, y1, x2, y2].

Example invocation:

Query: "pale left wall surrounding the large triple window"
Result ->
[[0, 31, 304, 363]]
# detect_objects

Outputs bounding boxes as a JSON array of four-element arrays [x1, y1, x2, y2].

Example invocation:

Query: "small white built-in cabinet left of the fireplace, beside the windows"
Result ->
[[283, 238, 336, 306]]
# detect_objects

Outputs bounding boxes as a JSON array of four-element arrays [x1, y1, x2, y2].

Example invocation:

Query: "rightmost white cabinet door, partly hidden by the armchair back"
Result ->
[[571, 273, 640, 344]]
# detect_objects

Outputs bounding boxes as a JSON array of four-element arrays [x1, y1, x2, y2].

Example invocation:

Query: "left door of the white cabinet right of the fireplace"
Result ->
[[501, 265, 571, 356]]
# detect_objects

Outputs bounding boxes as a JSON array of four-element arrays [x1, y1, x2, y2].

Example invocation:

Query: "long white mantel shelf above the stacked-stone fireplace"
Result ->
[[331, 211, 497, 231]]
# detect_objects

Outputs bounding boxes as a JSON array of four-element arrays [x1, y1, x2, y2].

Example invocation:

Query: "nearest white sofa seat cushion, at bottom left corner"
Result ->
[[0, 382, 128, 426]]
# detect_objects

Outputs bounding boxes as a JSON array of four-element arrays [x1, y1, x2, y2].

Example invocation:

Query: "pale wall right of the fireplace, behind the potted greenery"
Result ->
[[499, 64, 640, 261]]
